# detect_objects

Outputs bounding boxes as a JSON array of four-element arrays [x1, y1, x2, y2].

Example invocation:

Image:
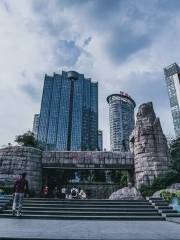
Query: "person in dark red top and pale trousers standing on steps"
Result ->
[[12, 173, 29, 216]]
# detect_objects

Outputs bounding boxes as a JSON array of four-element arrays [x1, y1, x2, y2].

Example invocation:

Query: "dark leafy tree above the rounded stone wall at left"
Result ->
[[15, 131, 42, 149]]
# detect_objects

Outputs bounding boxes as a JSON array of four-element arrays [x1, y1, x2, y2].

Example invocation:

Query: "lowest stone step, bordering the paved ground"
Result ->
[[0, 214, 165, 221]]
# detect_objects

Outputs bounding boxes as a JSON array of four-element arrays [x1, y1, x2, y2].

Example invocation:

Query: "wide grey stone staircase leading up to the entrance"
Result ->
[[0, 198, 165, 221]]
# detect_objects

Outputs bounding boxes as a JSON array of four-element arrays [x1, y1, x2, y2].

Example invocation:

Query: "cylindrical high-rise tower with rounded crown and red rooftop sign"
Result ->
[[107, 92, 136, 151]]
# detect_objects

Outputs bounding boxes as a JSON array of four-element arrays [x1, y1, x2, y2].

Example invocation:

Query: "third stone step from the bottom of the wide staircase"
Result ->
[[19, 206, 157, 212]]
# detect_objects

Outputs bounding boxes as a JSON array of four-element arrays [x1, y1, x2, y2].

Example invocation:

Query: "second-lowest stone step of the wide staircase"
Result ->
[[3, 210, 161, 216]]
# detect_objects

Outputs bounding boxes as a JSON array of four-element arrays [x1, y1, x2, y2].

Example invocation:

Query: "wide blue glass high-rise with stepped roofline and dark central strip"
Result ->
[[38, 71, 98, 151]]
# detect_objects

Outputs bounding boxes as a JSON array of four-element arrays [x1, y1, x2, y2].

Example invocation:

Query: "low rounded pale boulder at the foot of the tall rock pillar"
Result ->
[[109, 184, 143, 200]]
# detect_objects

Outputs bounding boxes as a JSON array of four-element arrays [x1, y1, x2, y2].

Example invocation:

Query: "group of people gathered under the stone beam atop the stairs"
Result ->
[[43, 185, 87, 200]]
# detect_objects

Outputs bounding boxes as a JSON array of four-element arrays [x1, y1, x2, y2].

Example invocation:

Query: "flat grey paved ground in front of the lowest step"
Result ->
[[0, 219, 180, 240]]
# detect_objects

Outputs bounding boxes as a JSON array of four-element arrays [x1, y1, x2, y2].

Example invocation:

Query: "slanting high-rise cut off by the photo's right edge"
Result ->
[[164, 63, 180, 137]]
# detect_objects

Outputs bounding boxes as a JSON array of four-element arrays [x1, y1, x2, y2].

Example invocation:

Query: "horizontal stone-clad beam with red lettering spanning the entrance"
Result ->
[[42, 151, 134, 169]]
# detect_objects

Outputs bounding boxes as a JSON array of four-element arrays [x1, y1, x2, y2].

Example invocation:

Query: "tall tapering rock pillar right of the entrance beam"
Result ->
[[130, 102, 171, 188]]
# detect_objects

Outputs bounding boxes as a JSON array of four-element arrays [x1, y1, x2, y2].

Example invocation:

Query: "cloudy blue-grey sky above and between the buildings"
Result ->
[[0, 0, 180, 149]]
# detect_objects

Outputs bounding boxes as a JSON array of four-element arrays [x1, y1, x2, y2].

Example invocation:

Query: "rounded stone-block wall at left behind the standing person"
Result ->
[[0, 146, 42, 194]]
